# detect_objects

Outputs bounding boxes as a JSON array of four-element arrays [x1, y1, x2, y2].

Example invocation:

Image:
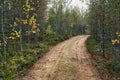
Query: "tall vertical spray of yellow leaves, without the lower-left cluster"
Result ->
[[23, 0, 38, 34]]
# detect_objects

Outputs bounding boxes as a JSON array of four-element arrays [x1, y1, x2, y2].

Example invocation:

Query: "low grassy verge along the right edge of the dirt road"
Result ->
[[86, 37, 120, 80]]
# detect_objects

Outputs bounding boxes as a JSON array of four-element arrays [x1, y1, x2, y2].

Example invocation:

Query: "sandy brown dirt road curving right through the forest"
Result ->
[[18, 35, 101, 80]]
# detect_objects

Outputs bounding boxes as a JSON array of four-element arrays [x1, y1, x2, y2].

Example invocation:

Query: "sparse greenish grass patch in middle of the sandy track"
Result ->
[[51, 60, 77, 80]]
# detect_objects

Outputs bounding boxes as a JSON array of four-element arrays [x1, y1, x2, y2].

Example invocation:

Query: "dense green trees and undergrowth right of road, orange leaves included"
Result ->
[[87, 0, 120, 80]]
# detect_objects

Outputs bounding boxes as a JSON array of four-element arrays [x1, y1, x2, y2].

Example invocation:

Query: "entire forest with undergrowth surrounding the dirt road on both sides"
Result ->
[[0, 0, 120, 80]]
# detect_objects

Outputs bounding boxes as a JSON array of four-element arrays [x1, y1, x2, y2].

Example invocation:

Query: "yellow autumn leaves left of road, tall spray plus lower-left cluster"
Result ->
[[9, 0, 40, 37]]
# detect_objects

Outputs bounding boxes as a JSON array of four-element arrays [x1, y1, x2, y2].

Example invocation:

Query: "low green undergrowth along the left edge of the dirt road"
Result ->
[[0, 34, 67, 80]]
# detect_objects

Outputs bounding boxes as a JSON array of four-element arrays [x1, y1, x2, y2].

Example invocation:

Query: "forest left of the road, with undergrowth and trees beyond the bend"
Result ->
[[0, 0, 86, 80]]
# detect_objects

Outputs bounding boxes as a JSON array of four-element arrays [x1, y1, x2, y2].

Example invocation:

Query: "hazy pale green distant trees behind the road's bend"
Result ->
[[48, 3, 86, 35]]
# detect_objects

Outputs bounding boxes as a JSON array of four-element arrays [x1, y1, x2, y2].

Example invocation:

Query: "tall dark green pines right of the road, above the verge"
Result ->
[[89, 0, 120, 62]]
